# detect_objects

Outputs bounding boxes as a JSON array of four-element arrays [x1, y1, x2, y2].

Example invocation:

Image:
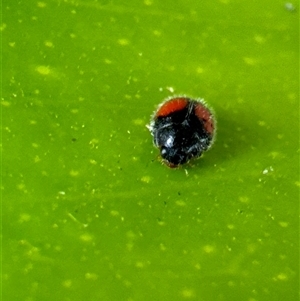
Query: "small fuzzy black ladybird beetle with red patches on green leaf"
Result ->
[[147, 96, 216, 168]]
